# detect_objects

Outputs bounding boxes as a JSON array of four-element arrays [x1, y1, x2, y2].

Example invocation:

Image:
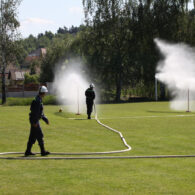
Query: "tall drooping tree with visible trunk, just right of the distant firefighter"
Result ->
[[83, 0, 134, 102]]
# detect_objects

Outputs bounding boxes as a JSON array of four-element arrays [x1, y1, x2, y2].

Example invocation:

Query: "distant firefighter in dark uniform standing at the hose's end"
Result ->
[[85, 83, 95, 119]]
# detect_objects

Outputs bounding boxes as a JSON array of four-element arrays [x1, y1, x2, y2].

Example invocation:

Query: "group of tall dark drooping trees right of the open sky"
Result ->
[[80, 0, 194, 101]]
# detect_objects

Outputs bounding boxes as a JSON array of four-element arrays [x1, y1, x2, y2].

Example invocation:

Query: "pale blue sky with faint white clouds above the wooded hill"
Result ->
[[18, 0, 84, 38]]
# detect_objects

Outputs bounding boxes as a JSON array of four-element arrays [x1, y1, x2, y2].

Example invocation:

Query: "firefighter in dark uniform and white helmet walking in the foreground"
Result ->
[[25, 86, 50, 156]]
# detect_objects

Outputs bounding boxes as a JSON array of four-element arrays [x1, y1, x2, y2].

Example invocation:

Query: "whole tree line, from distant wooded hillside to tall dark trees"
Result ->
[[3, 0, 195, 101]]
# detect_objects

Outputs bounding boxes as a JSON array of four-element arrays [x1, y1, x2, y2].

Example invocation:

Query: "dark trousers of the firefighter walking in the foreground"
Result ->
[[26, 123, 45, 153]]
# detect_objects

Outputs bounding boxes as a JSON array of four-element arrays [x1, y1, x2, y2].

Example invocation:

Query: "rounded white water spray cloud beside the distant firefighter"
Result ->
[[53, 60, 89, 114]]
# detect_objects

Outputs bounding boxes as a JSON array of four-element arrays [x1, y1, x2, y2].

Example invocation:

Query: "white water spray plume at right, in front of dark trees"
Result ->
[[155, 39, 195, 111]]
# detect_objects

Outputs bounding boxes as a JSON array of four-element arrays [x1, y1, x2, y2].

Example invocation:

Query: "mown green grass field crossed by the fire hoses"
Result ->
[[0, 102, 195, 195]]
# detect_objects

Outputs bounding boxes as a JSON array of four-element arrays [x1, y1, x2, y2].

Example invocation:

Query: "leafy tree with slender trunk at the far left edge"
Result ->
[[0, 0, 20, 104]]
